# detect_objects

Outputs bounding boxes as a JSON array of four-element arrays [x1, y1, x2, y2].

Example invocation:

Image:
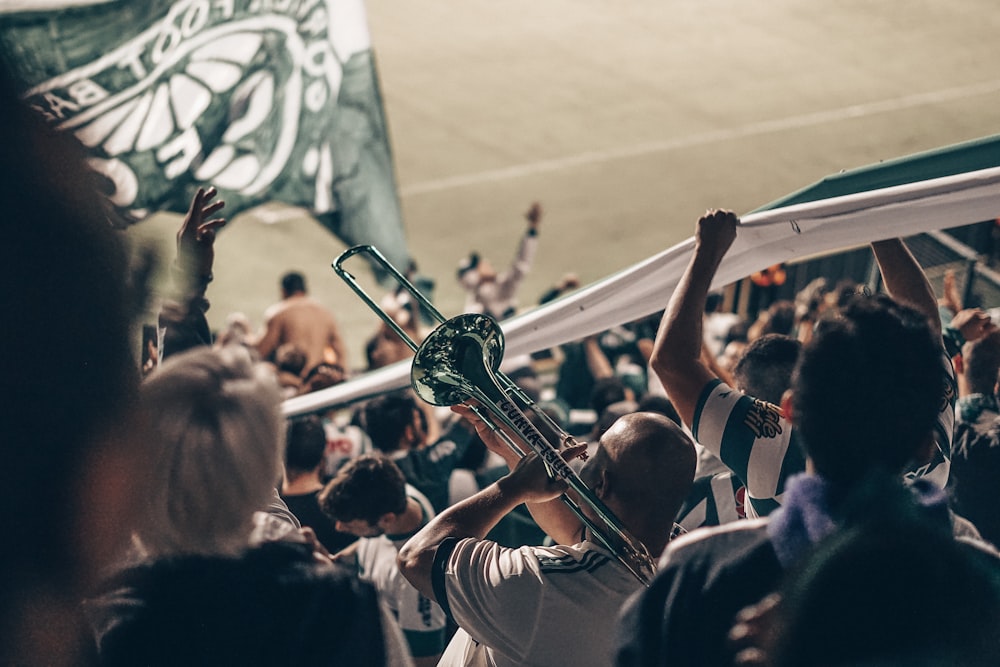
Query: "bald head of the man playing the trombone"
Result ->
[[580, 412, 696, 555]]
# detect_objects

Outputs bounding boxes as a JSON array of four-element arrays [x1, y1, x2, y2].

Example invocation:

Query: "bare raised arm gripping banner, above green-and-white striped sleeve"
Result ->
[[650, 211, 739, 427]]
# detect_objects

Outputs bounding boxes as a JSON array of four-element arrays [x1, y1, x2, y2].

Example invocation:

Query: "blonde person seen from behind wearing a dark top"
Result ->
[[87, 346, 407, 665]]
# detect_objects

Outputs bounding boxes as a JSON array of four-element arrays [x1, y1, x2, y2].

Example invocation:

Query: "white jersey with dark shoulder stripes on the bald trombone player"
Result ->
[[434, 538, 642, 667]]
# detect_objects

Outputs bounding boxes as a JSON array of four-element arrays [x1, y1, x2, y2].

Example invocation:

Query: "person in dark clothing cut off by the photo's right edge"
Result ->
[[948, 324, 1000, 545]]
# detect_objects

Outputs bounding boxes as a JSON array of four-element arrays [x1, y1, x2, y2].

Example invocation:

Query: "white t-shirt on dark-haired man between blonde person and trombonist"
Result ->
[[357, 485, 447, 658]]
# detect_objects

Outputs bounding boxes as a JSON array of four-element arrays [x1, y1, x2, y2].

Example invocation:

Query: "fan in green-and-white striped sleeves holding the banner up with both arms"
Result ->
[[652, 211, 955, 517]]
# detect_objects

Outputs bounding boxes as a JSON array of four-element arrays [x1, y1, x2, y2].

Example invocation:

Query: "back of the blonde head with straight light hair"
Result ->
[[139, 346, 284, 555]]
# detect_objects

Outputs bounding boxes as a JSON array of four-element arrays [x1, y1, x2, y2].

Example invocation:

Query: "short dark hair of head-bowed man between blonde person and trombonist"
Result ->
[[319, 454, 406, 525]]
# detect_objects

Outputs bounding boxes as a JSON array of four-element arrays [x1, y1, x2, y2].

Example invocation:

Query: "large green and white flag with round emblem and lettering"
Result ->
[[0, 0, 409, 267]]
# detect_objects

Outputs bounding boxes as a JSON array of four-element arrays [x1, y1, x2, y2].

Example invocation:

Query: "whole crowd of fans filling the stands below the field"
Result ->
[[0, 49, 1000, 667]]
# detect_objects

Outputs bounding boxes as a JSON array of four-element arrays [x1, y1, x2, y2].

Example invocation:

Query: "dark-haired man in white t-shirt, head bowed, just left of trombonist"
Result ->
[[319, 454, 447, 667]]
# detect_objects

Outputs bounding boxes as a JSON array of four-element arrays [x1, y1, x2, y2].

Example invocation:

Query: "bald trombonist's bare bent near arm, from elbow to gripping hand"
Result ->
[[397, 448, 582, 603]]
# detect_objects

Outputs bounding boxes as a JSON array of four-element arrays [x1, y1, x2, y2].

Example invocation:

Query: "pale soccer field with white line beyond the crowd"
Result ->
[[136, 0, 1000, 364]]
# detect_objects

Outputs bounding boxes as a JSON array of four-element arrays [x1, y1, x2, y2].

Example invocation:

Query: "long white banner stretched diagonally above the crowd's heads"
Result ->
[[284, 168, 1000, 416]]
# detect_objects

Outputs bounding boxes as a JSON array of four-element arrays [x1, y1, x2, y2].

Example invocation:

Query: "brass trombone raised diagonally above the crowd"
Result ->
[[332, 245, 655, 586]]
